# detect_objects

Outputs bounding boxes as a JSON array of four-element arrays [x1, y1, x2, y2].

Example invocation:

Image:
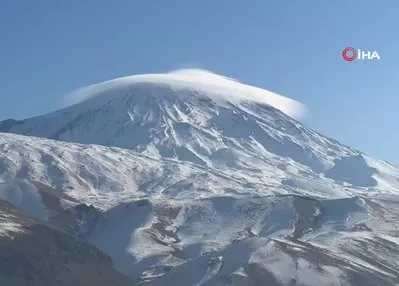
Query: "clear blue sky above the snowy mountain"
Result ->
[[0, 0, 399, 163]]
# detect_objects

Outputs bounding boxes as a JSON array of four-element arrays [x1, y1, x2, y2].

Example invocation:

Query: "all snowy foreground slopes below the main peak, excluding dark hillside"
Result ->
[[0, 133, 399, 285]]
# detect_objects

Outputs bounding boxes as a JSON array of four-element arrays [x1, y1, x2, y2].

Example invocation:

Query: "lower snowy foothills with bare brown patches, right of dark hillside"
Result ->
[[85, 193, 399, 286]]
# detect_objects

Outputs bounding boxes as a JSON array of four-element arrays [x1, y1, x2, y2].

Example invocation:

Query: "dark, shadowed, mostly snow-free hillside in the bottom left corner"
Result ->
[[0, 200, 134, 286]]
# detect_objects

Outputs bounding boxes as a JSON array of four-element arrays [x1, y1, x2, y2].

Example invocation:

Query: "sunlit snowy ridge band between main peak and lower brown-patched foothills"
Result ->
[[0, 133, 399, 209]]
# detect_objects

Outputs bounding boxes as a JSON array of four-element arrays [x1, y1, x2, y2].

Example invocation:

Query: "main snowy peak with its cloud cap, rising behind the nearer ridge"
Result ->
[[0, 71, 357, 171]]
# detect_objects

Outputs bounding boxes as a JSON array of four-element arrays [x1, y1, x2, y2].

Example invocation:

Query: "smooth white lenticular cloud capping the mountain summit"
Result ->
[[65, 69, 306, 119]]
